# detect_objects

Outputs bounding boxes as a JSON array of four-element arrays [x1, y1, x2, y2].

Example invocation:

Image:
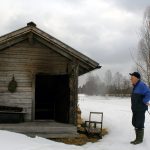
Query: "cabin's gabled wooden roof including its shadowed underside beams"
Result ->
[[0, 22, 101, 75]]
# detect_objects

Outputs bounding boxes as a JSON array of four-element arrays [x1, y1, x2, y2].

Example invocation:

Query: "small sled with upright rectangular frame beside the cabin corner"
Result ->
[[85, 112, 103, 139]]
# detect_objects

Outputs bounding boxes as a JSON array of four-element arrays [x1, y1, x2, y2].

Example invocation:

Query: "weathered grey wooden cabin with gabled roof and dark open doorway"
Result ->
[[0, 22, 100, 125]]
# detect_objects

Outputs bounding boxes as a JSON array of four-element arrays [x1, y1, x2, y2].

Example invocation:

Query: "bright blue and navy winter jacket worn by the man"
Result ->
[[131, 80, 150, 111]]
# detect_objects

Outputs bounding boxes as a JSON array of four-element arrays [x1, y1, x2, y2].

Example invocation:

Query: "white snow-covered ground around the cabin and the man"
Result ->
[[0, 95, 150, 150]]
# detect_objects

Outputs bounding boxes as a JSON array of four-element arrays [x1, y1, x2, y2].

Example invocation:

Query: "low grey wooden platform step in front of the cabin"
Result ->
[[0, 122, 78, 138]]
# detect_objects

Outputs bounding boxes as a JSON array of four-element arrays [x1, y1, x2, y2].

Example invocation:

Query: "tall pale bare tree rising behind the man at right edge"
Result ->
[[136, 7, 150, 86]]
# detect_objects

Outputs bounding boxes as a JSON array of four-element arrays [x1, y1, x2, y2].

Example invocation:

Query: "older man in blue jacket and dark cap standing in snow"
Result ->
[[129, 72, 150, 144]]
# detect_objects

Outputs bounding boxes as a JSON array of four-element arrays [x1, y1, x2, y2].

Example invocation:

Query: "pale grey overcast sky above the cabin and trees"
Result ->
[[0, 0, 150, 84]]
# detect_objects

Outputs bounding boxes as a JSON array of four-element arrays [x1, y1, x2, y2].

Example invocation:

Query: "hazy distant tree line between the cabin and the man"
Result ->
[[78, 70, 132, 96]]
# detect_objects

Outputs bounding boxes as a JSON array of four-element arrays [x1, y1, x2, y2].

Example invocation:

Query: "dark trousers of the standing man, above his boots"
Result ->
[[132, 110, 145, 129]]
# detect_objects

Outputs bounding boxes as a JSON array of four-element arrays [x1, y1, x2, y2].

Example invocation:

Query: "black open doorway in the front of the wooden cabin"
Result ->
[[35, 74, 70, 123]]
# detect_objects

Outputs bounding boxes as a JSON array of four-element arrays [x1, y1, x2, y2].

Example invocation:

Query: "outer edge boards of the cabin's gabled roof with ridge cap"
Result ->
[[0, 22, 101, 73]]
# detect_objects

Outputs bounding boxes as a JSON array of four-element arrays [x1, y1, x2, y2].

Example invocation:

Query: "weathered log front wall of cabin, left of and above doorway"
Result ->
[[0, 41, 73, 122]]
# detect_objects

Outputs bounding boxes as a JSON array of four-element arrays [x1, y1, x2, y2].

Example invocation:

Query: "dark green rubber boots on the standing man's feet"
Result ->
[[131, 129, 144, 145]]
